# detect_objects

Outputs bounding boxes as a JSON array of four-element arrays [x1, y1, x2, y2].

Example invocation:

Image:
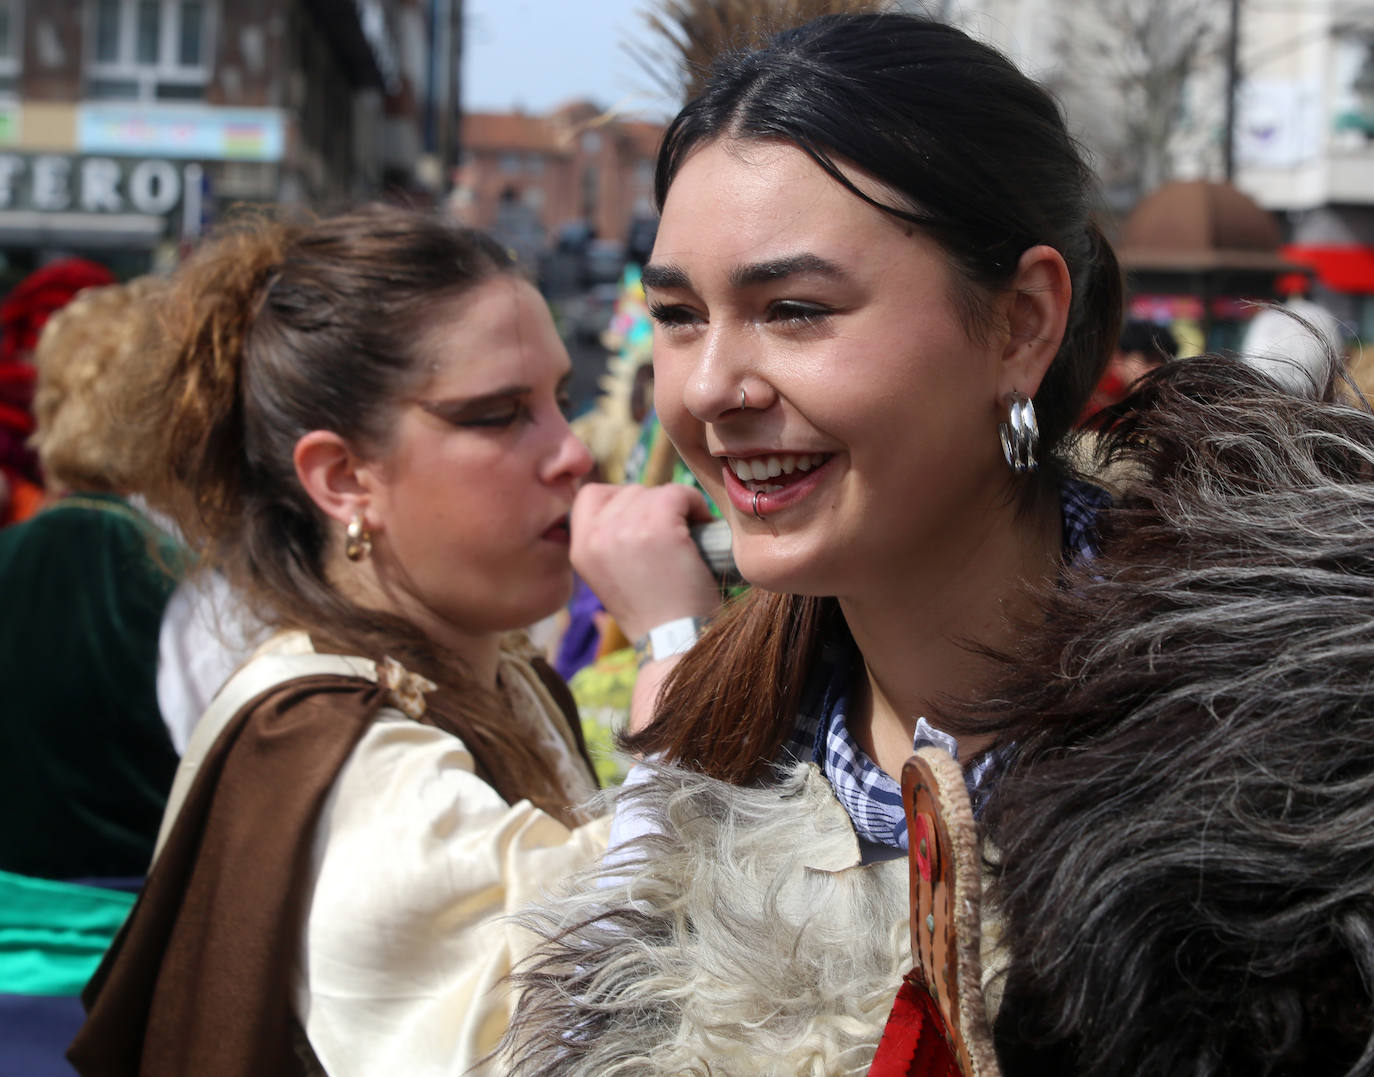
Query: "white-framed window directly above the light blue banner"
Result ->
[[85, 0, 213, 100]]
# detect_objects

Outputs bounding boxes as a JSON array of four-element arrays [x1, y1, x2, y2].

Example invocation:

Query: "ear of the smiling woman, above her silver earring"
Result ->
[[1000, 243, 1073, 397]]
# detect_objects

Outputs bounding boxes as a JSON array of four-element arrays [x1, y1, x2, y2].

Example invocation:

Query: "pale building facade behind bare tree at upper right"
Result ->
[[951, 0, 1374, 342]]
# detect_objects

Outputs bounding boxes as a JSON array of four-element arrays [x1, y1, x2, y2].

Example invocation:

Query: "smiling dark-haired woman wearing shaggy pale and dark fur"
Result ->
[[508, 14, 1374, 1077]]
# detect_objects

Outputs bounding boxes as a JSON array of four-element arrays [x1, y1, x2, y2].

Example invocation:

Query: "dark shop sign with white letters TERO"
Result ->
[[0, 154, 192, 217]]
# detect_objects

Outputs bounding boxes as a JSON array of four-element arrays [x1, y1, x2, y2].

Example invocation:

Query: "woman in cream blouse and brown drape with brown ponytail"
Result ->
[[70, 209, 665, 1077]]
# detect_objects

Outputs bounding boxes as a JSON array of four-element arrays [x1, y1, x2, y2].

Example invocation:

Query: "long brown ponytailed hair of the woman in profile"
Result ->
[[139, 206, 585, 813]]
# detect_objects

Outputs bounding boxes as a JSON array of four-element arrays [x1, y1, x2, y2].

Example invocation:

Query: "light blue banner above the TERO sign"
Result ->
[[77, 104, 286, 161]]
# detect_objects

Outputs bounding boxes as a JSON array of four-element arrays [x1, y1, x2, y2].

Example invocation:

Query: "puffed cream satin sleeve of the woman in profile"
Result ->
[[295, 710, 609, 1077]]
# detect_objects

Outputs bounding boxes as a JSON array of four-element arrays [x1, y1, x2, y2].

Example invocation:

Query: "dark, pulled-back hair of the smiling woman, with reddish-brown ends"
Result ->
[[627, 12, 1123, 782]]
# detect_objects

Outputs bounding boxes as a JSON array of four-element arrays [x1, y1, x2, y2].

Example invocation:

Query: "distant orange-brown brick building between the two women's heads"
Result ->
[[453, 102, 664, 262]]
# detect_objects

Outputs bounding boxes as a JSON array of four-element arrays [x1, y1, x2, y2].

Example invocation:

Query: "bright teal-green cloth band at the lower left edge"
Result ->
[[0, 871, 135, 996]]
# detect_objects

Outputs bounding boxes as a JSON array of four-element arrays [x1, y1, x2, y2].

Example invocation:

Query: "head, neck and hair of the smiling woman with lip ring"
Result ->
[[585, 6, 1121, 780]]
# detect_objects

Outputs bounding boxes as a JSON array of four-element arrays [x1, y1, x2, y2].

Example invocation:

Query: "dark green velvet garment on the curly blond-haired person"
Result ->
[[0, 495, 177, 879]]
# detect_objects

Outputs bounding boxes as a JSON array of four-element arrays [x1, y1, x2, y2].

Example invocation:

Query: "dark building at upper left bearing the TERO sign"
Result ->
[[0, 0, 460, 276]]
